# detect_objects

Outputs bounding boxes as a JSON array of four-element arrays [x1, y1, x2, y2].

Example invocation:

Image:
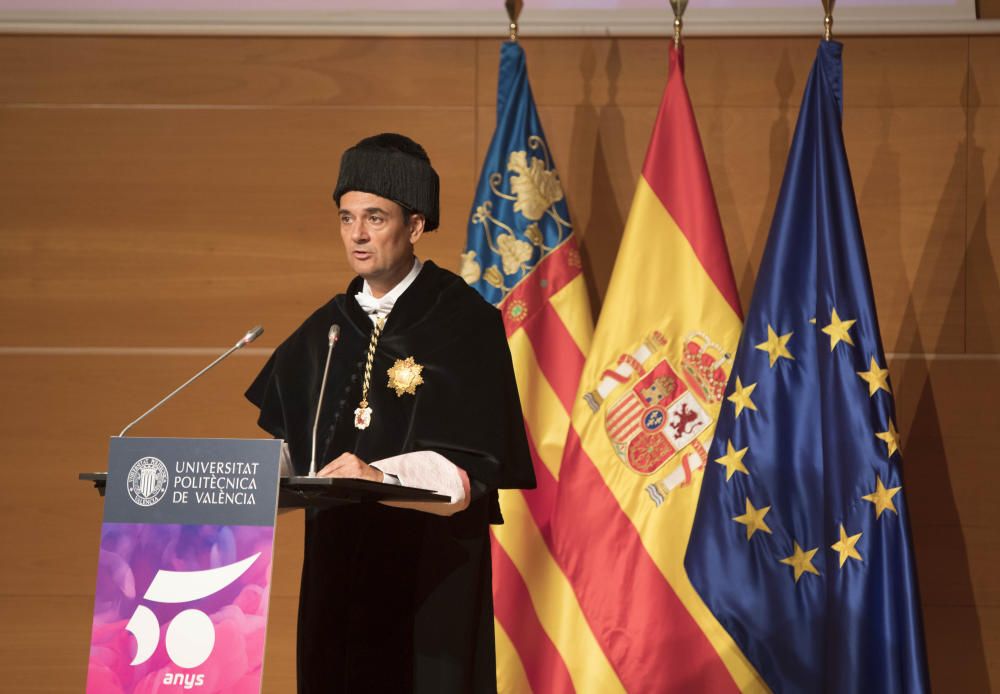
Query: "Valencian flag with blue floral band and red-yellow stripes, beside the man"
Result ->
[[460, 41, 614, 693]]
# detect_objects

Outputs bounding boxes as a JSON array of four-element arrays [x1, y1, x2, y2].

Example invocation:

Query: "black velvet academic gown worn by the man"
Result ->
[[247, 262, 535, 694]]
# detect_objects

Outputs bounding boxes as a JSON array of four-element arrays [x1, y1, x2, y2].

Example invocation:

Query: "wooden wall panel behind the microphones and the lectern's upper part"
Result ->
[[0, 356, 302, 596]]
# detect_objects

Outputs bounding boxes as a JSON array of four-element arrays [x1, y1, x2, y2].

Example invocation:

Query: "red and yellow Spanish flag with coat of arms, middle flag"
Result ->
[[552, 45, 759, 693]]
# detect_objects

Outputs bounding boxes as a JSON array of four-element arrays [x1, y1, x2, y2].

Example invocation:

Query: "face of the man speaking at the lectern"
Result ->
[[340, 191, 424, 297]]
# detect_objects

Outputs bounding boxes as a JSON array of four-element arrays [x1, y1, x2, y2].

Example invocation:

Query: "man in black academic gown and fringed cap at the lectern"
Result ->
[[247, 134, 535, 693]]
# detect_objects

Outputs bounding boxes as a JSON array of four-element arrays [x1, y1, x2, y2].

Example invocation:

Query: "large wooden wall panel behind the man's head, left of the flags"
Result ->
[[0, 108, 474, 346]]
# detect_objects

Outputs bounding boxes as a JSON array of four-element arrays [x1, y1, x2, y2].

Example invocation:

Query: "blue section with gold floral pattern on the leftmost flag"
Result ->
[[460, 41, 575, 308]]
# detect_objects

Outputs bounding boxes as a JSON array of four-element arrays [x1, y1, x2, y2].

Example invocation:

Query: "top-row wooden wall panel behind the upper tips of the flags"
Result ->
[[477, 37, 968, 108]]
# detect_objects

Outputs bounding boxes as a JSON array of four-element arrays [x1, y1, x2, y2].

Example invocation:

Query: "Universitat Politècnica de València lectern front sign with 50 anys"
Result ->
[[87, 438, 281, 694]]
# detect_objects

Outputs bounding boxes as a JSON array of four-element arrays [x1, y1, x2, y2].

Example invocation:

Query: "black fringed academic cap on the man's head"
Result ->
[[333, 133, 441, 231]]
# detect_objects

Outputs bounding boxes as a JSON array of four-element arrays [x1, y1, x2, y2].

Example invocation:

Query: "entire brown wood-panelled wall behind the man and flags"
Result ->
[[0, 34, 1000, 692]]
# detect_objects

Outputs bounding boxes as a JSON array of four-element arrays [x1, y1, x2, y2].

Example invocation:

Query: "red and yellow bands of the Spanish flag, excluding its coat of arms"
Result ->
[[549, 49, 764, 692]]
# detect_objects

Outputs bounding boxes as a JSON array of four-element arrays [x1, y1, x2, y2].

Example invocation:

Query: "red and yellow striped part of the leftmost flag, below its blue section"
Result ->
[[493, 237, 622, 694]]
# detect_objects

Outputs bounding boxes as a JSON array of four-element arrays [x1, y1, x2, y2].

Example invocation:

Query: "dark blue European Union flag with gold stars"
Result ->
[[686, 41, 927, 692]]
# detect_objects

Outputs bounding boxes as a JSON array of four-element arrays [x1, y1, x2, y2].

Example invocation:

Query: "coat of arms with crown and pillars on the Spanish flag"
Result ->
[[584, 332, 731, 506]]
